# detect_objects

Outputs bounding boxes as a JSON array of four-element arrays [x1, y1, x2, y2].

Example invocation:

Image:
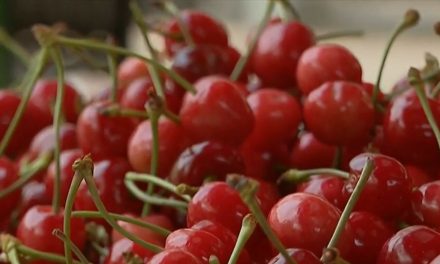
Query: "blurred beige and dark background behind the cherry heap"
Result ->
[[0, 0, 440, 97]]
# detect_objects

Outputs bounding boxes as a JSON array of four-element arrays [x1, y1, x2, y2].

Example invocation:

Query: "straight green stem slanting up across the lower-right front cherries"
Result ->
[[327, 158, 374, 260]]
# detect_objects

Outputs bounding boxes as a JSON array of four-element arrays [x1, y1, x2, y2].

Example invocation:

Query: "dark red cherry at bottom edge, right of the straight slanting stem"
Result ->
[[348, 211, 394, 264]]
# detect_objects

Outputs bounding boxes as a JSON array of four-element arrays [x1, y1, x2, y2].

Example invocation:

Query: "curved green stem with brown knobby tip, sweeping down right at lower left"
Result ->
[[73, 156, 162, 253]]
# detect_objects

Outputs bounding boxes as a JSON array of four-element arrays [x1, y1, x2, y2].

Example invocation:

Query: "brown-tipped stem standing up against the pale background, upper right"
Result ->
[[371, 9, 420, 107]]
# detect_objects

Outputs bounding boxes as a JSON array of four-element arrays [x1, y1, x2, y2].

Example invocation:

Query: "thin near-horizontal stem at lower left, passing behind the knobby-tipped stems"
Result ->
[[72, 211, 171, 237]]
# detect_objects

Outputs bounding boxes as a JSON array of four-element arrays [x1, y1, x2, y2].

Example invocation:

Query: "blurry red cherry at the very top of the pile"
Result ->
[[165, 10, 228, 56]]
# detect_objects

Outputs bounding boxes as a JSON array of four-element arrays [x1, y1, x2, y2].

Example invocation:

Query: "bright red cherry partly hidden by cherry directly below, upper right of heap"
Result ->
[[296, 44, 362, 94]]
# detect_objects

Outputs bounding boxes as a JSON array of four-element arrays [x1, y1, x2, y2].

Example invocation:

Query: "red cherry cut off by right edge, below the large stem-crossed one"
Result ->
[[411, 180, 440, 228]]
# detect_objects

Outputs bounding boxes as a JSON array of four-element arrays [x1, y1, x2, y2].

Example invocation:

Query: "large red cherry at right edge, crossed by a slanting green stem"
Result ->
[[383, 90, 440, 166]]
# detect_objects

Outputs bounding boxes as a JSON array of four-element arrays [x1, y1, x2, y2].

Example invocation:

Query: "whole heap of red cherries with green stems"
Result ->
[[0, 1, 440, 264]]
